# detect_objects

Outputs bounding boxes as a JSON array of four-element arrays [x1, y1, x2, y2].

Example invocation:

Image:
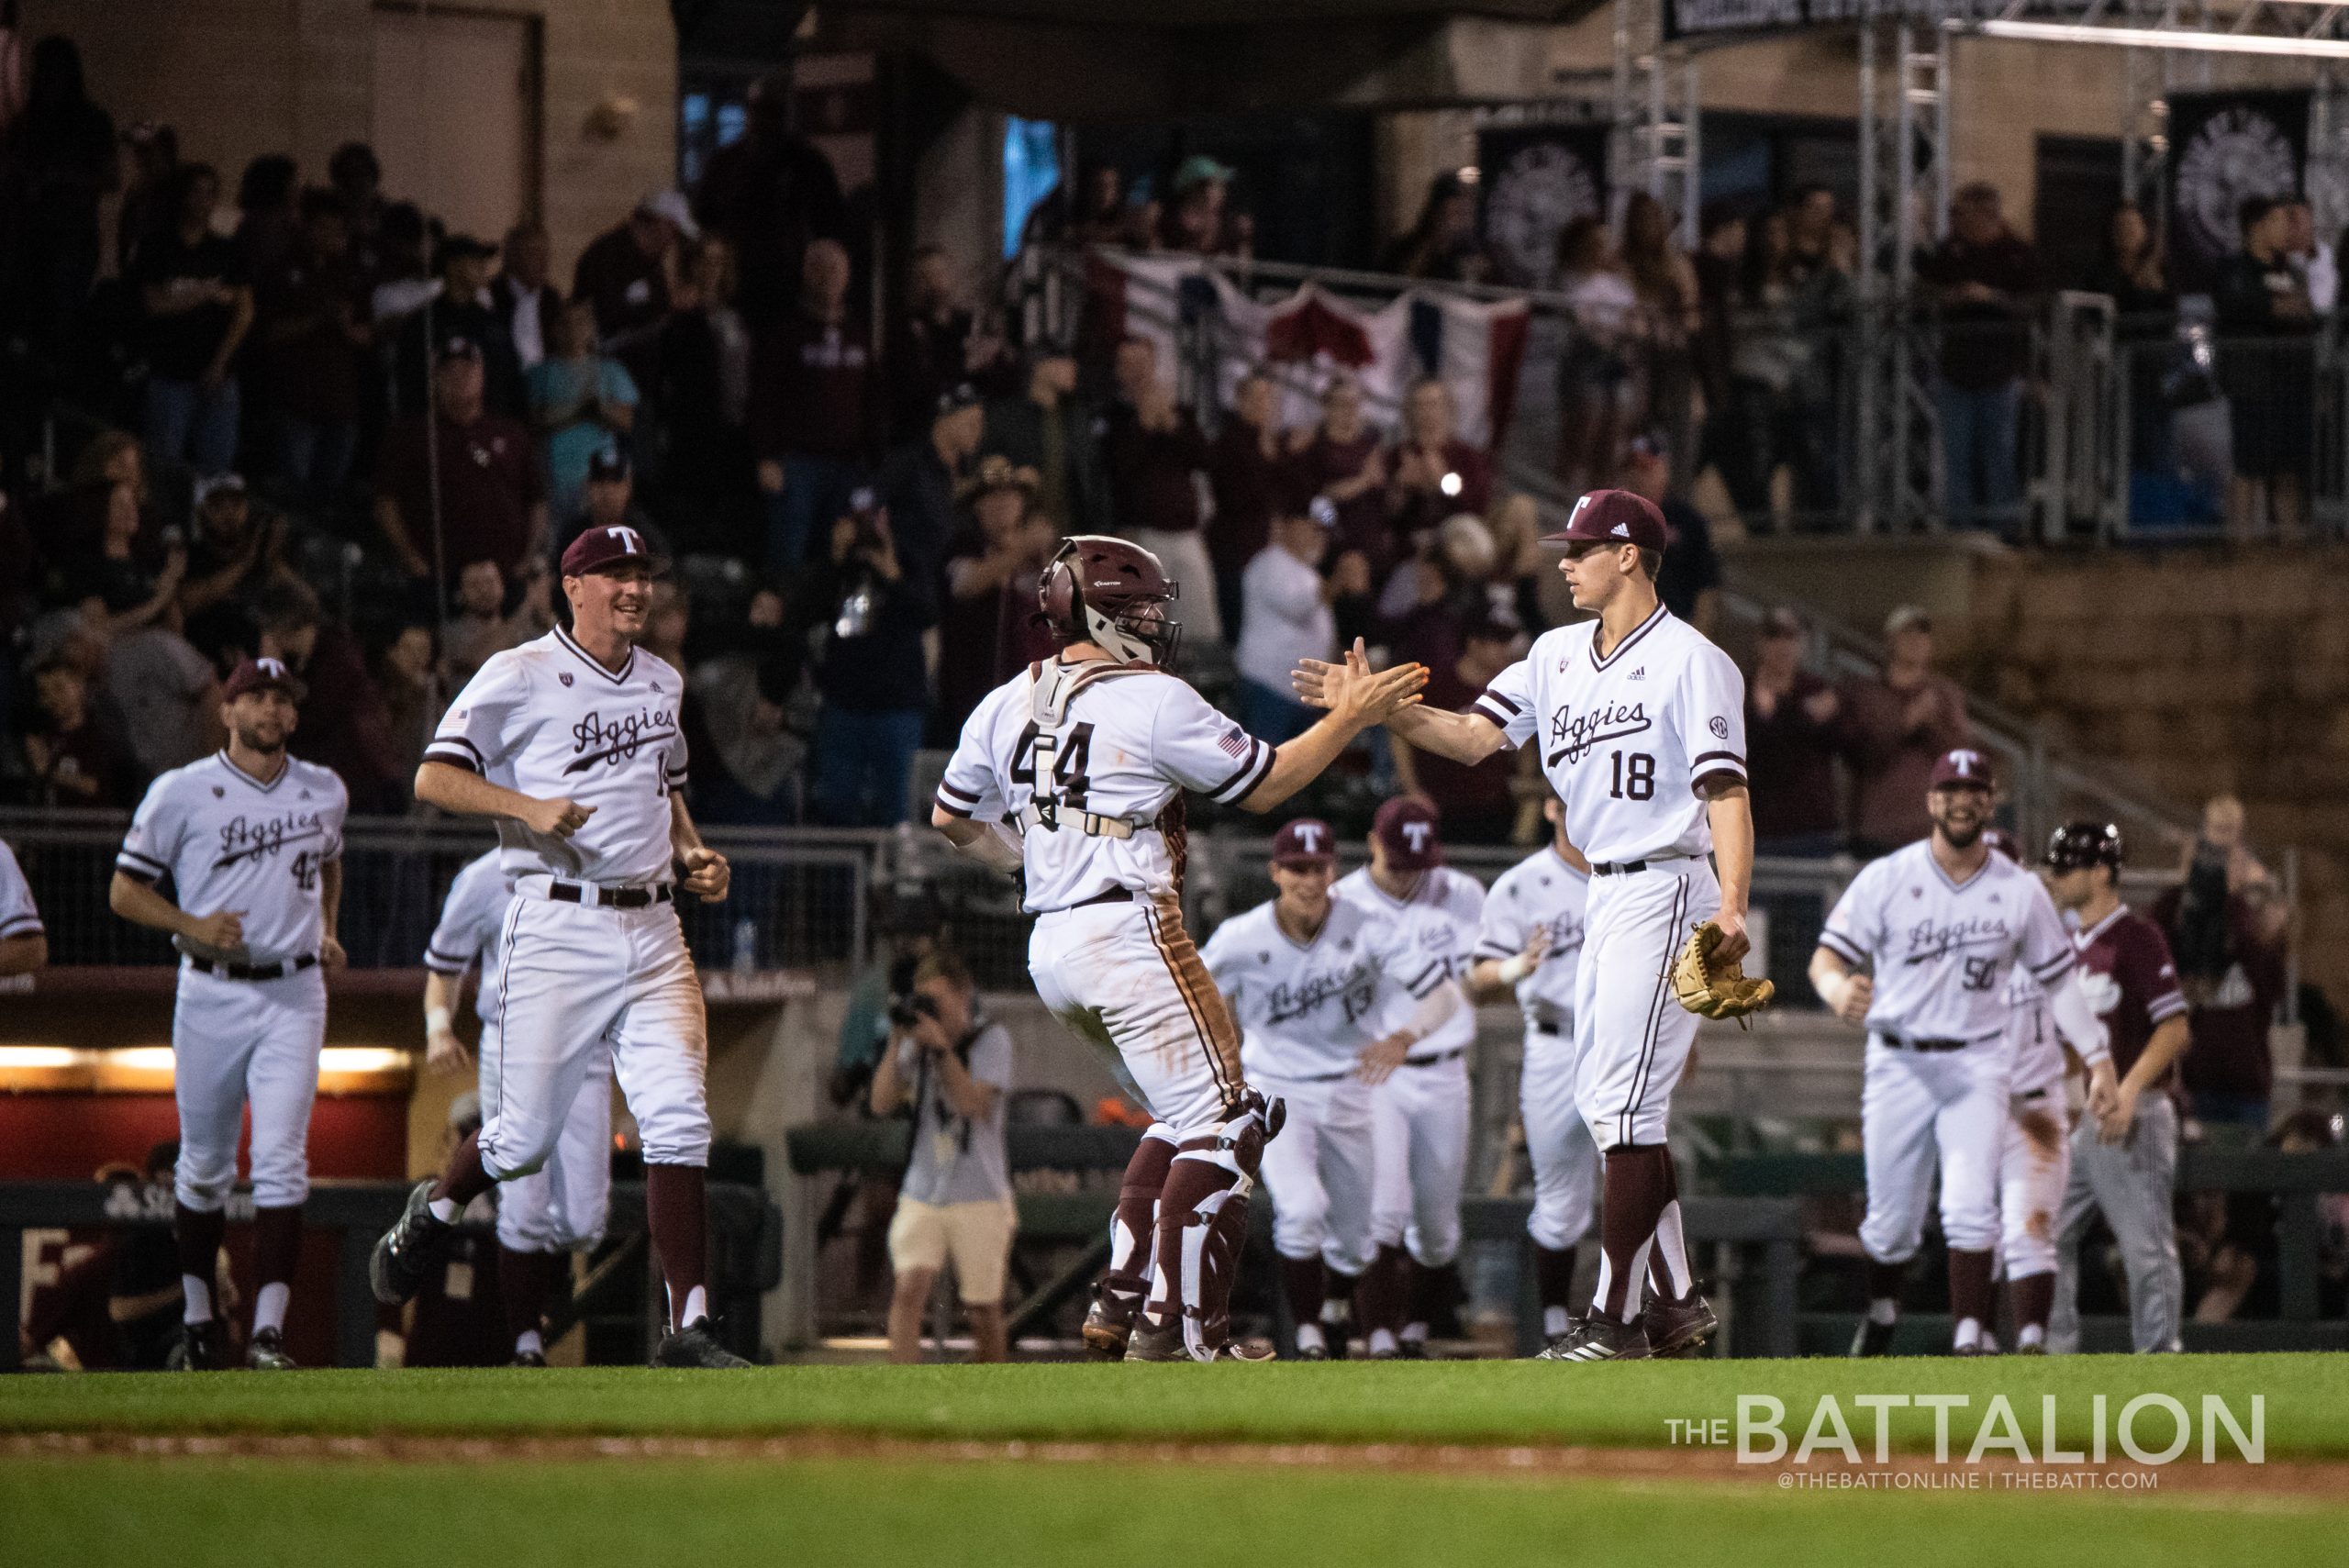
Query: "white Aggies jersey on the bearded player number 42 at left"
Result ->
[[115, 751, 350, 964]]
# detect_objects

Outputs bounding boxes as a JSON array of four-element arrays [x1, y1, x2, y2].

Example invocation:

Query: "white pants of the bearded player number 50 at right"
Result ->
[[1861, 1035, 2006, 1262]]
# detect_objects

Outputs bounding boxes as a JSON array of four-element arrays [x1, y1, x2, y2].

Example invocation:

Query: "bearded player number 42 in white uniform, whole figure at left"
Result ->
[[108, 660, 350, 1371]]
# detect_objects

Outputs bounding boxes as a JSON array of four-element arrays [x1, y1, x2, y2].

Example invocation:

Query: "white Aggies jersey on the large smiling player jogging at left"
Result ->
[[425, 627, 686, 885]]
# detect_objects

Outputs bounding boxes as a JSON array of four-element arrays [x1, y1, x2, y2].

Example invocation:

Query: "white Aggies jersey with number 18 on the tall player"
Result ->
[[1471, 606, 1745, 863]]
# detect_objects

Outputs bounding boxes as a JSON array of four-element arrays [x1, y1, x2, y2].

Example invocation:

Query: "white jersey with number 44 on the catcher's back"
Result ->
[[937, 660, 1274, 913]]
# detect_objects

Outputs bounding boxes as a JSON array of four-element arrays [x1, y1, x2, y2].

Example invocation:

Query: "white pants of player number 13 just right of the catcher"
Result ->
[[1254, 1073, 1376, 1274]]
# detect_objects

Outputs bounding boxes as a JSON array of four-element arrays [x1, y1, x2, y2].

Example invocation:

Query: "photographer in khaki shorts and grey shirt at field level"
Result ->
[[872, 953, 1019, 1363]]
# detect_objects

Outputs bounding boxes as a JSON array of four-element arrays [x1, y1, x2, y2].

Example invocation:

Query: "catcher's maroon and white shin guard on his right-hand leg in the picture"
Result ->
[[1149, 1089, 1283, 1362]]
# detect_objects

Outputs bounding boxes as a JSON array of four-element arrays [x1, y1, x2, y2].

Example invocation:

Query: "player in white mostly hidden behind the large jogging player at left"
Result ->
[[425, 850, 611, 1366]]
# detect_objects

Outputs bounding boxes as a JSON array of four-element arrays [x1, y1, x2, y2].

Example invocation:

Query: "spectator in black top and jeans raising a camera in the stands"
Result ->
[[792, 488, 940, 828]]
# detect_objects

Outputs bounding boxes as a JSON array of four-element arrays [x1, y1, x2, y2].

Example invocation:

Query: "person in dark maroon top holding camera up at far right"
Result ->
[[2149, 795, 2293, 1134]]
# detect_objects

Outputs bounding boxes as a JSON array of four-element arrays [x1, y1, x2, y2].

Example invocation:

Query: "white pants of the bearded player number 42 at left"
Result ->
[[172, 964, 327, 1214]]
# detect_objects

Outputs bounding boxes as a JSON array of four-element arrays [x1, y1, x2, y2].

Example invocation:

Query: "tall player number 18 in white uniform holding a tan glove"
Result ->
[[1297, 491, 1753, 1362]]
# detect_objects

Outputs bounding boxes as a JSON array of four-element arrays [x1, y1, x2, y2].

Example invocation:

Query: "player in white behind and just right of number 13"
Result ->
[[1343, 795, 1485, 1359]]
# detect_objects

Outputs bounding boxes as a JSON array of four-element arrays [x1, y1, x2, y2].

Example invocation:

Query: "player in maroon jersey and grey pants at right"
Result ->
[[2046, 821, 2191, 1354]]
